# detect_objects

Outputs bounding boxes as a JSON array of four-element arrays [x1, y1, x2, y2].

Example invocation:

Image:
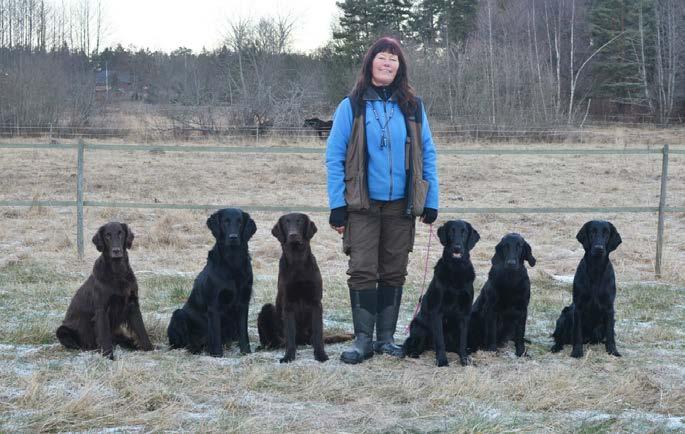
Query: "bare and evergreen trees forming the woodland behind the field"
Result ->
[[0, 0, 685, 132]]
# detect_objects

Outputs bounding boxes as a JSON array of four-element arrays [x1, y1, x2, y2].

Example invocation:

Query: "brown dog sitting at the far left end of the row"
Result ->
[[56, 222, 152, 360]]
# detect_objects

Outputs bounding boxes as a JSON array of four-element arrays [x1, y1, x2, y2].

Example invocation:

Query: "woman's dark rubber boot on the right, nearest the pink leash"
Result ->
[[373, 286, 404, 358]]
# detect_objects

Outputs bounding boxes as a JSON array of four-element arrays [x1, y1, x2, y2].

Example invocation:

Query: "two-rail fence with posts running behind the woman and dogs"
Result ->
[[0, 141, 685, 277]]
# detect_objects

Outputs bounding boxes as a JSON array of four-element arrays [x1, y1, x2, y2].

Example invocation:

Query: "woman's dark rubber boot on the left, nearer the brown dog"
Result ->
[[340, 288, 377, 364]]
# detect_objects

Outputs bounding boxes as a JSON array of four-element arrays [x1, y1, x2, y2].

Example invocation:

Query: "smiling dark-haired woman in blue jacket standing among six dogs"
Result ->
[[326, 37, 438, 363]]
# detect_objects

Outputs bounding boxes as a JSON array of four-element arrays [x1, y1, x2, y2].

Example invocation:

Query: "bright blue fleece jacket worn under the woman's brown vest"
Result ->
[[326, 98, 438, 209]]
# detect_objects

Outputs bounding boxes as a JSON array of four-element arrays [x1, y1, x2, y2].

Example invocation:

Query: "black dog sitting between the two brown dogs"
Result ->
[[167, 208, 257, 357]]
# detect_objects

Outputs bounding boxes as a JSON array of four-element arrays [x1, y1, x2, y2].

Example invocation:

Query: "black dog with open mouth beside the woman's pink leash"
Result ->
[[404, 220, 480, 366]]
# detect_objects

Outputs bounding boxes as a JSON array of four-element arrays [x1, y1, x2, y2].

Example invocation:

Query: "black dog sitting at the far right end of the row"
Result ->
[[552, 220, 621, 357]]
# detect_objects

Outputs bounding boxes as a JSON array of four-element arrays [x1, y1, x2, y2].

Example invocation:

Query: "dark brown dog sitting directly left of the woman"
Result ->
[[257, 213, 351, 363]]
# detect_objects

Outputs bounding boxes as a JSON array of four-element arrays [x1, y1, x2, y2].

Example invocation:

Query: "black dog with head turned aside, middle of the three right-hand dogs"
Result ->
[[469, 233, 535, 357]]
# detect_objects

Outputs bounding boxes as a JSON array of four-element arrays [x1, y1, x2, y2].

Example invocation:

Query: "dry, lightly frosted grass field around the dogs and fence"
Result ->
[[0, 134, 685, 432]]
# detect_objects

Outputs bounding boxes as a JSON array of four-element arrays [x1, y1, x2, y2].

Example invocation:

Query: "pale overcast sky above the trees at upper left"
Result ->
[[103, 0, 338, 51]]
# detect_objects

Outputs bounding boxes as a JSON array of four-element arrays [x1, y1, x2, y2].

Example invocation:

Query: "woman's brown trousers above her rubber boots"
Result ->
[[343, 199, 416, 290]]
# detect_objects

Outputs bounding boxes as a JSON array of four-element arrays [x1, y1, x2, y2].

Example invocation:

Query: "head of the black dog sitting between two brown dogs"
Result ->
[[207, 208, 257, 248]]
